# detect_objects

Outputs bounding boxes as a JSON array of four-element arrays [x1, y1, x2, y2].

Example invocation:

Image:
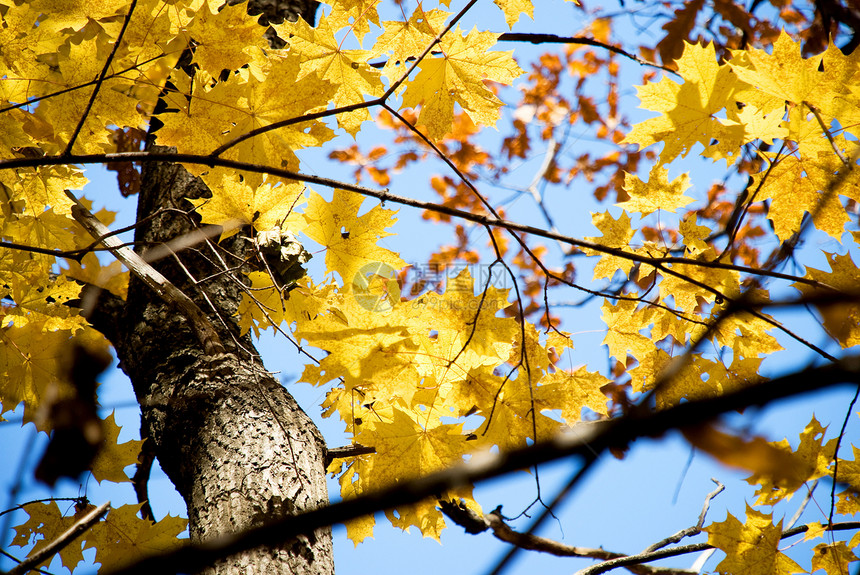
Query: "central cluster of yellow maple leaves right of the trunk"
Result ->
[[239, 190, 609, 542]]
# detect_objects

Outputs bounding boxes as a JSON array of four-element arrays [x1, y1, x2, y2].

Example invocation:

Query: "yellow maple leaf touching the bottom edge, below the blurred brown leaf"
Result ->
[[704, 505, 805, 575]]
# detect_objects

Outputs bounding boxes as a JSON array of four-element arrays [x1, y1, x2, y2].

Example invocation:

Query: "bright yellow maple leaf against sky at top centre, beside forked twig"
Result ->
[[403, 26, 523, 140]]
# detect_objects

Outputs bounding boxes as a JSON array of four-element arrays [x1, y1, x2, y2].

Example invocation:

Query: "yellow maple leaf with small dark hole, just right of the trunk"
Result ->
[[304, 189, 406, 286]]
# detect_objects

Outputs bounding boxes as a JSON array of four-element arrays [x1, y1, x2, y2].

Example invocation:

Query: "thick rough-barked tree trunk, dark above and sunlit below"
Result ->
[[97, 0, 334, 575]]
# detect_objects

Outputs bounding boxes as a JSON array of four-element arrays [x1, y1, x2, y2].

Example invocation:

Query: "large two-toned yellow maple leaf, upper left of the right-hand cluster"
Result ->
[[623, 44, 744, 164]]
